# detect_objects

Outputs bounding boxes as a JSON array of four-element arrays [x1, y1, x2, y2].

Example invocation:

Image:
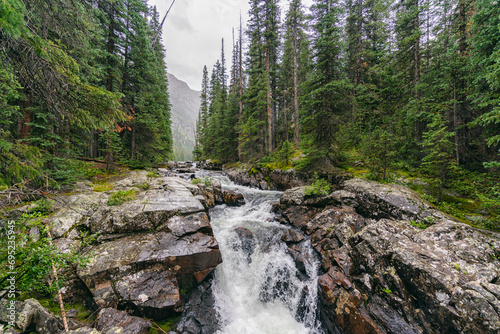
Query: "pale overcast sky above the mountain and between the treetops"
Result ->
[[148, 0, 312, 90]]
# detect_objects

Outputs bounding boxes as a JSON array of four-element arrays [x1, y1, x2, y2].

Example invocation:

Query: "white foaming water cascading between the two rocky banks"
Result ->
[[198, 175, 322, 334]]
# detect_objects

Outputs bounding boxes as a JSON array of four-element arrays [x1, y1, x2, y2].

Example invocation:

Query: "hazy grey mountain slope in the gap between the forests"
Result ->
[[167, 73, 200, 161]]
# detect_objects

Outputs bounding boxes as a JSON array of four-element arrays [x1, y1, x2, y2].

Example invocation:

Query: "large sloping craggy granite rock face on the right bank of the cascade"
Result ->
[[275, 180, 500, 334]]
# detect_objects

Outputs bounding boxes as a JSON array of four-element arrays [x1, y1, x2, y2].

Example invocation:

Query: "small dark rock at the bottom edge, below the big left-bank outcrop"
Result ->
[[95, 308, 153, 334]]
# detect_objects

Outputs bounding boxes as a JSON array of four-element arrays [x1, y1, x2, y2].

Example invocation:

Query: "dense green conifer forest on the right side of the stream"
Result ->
[[194, 0, 500, 227]]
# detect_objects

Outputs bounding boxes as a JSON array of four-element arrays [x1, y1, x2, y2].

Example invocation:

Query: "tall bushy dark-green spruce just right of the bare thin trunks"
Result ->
[[301, 0, 352, 164]]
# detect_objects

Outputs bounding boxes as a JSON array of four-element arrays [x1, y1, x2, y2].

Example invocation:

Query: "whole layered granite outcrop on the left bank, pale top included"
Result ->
[[40, 171, 222, 324]]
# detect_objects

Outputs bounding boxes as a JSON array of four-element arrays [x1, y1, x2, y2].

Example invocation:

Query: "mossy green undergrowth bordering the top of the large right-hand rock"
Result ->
[[341, 151, 500, 230]]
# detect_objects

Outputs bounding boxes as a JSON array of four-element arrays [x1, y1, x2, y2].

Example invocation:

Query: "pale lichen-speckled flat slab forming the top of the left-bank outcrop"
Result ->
[[51, 171, 205, 238]]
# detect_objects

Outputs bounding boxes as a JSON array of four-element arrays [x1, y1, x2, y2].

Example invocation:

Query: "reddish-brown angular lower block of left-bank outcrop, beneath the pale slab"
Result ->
[[78, 232, 222, 316]]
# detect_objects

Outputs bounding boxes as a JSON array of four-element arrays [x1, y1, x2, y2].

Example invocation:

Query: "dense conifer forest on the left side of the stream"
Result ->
[[0, 0, 172, 188]]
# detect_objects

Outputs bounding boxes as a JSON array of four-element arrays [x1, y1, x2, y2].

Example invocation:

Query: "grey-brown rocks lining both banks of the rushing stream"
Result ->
[[0, 164, 500, 334]]
